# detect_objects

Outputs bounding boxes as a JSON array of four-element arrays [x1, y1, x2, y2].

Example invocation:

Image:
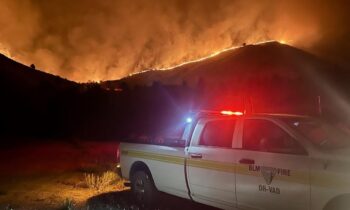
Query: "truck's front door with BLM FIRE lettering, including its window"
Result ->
[[235, 119, 310, 210]]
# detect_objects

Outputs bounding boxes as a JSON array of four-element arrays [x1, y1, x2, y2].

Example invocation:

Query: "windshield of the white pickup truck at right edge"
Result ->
[[281, 118, 350, 149]]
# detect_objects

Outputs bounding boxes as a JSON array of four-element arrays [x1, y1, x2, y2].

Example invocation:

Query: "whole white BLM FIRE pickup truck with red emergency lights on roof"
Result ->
[[119, 111, 350, 210]]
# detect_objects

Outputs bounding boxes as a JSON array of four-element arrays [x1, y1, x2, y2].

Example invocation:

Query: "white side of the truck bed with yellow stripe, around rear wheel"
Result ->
[[120, 143, 189, 198]]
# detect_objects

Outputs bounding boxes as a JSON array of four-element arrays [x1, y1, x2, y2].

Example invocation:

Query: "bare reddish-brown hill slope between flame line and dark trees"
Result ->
[[105, 42, 343, 86]]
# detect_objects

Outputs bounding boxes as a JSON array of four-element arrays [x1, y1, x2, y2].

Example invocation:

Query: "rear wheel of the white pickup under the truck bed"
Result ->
[[131, 171, 158, 206]]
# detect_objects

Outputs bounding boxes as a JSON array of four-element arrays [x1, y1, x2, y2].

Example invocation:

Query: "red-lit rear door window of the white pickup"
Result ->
[[199, 120, 236, 148]]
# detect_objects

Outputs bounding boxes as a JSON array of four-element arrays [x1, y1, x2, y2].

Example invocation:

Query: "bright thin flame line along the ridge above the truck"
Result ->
[[129, 39, 288, 76]]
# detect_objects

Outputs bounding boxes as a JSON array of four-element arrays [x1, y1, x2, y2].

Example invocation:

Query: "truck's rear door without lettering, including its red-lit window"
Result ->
[[186, 119, 236, 209]]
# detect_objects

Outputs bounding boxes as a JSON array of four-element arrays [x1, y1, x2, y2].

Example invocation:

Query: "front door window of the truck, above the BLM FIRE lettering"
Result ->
[[243, 120, 305, 154]]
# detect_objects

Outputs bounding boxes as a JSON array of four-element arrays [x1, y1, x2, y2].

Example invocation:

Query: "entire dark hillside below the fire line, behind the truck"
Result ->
[[0, 42, 350, 143]]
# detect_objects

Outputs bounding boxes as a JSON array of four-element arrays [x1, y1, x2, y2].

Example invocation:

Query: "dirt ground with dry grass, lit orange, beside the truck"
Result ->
[[0, 142, 215, 210]]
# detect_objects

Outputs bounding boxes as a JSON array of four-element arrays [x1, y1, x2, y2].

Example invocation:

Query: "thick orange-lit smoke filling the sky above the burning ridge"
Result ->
[[0, 0, 350, 81]]
